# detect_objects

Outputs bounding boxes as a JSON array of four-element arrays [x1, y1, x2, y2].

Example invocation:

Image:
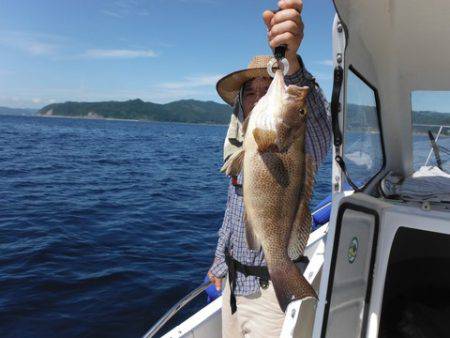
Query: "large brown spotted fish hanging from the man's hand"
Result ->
[[221, 70, 317, 312]]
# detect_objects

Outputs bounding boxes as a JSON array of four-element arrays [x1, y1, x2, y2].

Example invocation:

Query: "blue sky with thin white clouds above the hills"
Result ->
[[0, 0, 334, 107]]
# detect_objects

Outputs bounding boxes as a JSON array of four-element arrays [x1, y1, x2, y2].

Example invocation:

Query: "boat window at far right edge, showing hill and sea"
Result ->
[[411, 91, 450, 173]]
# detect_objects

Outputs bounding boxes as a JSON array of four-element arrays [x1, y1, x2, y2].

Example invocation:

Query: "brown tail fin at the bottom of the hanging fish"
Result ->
[[269, 259, 317, 312]]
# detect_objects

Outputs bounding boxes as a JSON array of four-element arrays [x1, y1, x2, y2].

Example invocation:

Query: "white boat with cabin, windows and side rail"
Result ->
[[146, 0, 450, 338]]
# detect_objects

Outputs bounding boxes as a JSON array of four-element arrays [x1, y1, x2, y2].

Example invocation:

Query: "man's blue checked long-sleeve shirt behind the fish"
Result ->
[[211, 60, 331, 295]]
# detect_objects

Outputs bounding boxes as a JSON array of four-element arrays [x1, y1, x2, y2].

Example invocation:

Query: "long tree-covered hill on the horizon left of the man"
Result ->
[[38, 99, 231, 124]]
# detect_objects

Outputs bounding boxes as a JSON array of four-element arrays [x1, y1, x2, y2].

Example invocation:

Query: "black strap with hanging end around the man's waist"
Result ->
[[225, 249, 309, 314]]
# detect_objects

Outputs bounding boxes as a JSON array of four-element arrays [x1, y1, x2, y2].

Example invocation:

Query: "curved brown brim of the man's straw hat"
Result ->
[[216, 68, 270, 107]]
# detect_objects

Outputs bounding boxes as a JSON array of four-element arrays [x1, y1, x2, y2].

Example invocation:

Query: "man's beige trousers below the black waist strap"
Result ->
[[222, 276, 284, 338]]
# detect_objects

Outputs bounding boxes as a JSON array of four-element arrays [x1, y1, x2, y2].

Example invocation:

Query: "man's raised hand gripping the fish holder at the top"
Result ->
[[263, 0, 304, 74]]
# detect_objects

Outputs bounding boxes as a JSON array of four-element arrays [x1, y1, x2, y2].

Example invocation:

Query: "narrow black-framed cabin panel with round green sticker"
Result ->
[[321, 203, 379, 338]]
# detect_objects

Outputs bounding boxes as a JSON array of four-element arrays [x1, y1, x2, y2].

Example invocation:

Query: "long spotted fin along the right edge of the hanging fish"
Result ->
[[288, 155, 315, 259]]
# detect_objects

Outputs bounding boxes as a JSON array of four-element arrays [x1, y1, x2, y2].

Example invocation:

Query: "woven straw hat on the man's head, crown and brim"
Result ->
[[216, 55, 277, 106]]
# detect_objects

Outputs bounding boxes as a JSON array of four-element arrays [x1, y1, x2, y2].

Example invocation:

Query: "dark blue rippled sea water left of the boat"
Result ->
[[0, 116, 330, 338]]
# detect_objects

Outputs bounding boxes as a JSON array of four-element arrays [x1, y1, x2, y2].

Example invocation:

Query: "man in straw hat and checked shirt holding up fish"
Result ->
[[208, 0, 331, 338]]
